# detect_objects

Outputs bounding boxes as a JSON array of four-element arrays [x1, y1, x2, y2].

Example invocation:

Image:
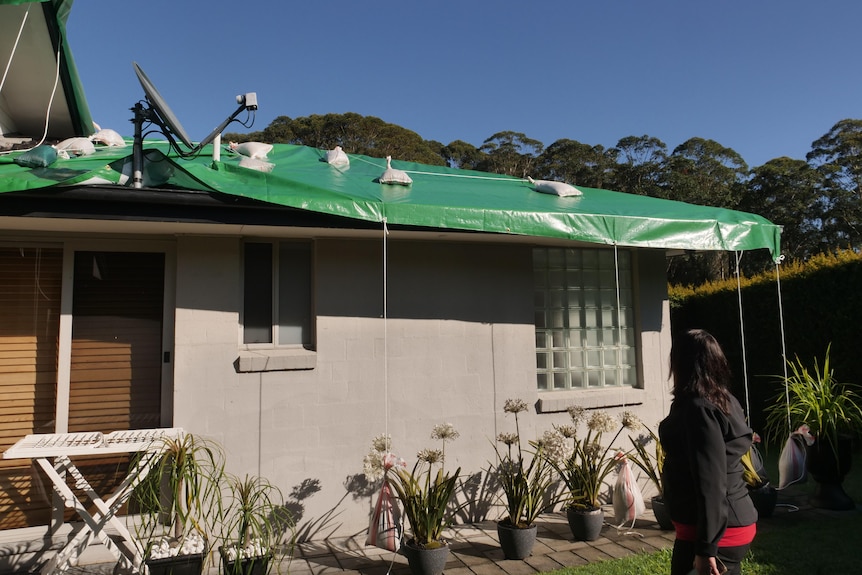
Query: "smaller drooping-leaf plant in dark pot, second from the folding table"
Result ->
[[219, 475, 292, 575]]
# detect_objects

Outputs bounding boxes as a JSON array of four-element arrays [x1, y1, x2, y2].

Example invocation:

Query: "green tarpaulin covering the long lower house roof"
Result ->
[[0, 141, 780, 258]]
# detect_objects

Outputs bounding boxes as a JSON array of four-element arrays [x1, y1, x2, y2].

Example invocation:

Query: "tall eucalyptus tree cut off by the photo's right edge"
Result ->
[[806, 119, 862, 249]]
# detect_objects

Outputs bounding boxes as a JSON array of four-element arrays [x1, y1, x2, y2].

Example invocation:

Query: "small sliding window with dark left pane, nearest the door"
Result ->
[[243, 242, 313, 347]]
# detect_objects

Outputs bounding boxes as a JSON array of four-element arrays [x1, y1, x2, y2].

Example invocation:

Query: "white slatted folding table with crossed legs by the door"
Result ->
[[3, 427, 182, 575]]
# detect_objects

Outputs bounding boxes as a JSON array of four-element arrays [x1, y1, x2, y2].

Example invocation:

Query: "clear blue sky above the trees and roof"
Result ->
[[68, 0, 862, 167]]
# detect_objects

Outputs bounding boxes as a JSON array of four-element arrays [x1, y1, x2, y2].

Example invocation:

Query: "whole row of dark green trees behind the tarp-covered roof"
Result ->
[[224, 112, 862, 283]]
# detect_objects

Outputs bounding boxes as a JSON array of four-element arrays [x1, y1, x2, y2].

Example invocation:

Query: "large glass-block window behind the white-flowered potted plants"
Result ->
[[533, 248, 637, 391]]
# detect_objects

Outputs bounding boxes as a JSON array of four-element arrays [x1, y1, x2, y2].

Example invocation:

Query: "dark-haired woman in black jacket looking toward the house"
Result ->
[[659, 329, 757, 575]]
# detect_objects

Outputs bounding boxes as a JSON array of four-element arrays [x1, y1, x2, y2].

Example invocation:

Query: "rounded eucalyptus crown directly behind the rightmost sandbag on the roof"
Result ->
[[536, 139, 616, 188]]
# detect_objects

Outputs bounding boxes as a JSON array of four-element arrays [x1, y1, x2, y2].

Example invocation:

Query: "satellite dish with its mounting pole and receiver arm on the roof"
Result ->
[[132, 62, 257, 188]]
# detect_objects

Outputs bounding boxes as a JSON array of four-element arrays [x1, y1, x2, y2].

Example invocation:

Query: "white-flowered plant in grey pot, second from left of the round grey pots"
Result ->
[[494, 399, 554, 559]]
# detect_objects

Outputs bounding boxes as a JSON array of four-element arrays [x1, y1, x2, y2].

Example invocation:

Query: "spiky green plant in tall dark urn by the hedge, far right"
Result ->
[[766, 345, 862, 510]]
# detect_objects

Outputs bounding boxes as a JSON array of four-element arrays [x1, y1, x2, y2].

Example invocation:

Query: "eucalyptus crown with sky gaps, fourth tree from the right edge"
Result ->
[[612, 135, 668, 197]]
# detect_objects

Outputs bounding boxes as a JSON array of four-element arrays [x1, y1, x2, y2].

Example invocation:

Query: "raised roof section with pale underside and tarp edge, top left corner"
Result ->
[[0, 0, 94, 141]]
